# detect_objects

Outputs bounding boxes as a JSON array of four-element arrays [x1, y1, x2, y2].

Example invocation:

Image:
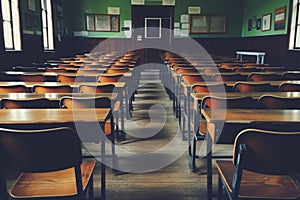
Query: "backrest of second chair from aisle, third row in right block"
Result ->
[[233, 82, 275, 92]]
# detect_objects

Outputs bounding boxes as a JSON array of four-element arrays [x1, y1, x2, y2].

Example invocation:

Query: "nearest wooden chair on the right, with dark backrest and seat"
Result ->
[[216, 129, 300, 200]]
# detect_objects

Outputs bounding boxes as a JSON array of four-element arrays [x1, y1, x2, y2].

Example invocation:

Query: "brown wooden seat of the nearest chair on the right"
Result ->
[[216, 161, 300, 199]]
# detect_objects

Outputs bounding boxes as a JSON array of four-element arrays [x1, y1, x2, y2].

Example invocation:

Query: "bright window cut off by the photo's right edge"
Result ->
[[289, 0, 300, 50]]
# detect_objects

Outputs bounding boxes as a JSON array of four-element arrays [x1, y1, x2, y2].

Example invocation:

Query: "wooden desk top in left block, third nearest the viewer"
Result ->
[[0, 81, 126, 88]]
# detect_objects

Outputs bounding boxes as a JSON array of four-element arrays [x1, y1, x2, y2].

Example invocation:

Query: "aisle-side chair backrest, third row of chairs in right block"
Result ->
[[192, 83, 229, 93]]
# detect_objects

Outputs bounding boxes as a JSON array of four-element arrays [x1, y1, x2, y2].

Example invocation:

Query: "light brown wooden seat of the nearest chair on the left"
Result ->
[[10, 161, 96, 198]]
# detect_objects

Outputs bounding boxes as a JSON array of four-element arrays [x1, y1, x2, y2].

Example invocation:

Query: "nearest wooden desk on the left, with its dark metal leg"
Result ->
[[0, 108, 112, 199]]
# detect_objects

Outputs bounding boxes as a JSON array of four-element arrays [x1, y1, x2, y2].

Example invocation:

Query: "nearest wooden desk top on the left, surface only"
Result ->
[[0, 108, 110, 125]]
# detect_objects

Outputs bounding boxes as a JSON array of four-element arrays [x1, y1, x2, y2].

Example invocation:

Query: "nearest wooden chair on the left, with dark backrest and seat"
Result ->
[[0, 127, 96, 200]]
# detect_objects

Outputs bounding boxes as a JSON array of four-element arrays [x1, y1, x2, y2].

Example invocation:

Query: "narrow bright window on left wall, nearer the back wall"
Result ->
[[41, 0, 54, 50]]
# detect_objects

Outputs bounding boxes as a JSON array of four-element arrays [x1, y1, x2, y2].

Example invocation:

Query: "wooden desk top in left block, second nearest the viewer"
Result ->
[[0, 93, 118, 100]]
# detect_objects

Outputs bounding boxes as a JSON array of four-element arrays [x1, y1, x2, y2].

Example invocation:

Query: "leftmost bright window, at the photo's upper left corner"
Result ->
[[1, 0, 21, 51]]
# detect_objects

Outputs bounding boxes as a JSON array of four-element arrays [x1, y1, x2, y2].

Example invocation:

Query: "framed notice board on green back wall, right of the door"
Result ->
[[189, 14, 226, 34]]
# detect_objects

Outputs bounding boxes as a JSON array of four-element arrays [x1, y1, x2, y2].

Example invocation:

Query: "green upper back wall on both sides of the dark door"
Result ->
[[63, 0, 242, 38]]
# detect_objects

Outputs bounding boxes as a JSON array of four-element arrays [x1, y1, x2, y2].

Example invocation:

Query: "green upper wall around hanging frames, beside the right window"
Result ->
[[242, 0, 289, 37]]
